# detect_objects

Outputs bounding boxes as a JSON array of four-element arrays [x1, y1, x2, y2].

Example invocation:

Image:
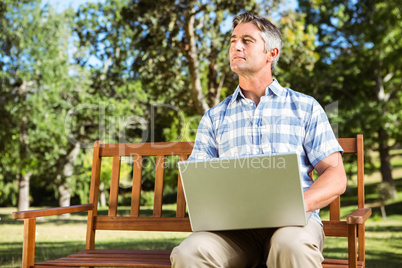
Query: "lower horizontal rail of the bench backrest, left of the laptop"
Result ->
[[94, 216, 191, 232]]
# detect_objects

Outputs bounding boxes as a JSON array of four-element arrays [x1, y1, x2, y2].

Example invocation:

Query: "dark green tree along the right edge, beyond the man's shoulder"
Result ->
[[299, 0, 402, 185]]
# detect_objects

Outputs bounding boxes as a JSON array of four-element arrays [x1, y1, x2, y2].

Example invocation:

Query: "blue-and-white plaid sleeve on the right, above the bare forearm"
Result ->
[[303, 100, 343, 166]]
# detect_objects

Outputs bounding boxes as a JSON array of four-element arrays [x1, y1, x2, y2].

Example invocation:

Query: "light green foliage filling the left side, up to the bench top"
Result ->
[[0, 1, 152, 207]]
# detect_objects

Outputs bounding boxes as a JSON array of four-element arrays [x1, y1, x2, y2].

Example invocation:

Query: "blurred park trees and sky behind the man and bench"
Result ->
[[0, 0, 402, 266]]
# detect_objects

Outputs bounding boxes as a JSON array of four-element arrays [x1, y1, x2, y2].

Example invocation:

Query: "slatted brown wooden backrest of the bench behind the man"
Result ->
[[86, 135, 364, 259]]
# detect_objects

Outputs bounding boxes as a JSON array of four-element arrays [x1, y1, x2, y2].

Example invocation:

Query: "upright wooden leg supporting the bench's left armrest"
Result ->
[[22, 219, 36, 268]]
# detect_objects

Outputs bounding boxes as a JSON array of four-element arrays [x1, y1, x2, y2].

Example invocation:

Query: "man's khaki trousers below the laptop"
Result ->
[[170, 219, 324, 268]]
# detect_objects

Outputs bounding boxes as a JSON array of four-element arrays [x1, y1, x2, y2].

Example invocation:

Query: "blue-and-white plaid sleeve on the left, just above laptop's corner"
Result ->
[[188, 112, 218, 160]]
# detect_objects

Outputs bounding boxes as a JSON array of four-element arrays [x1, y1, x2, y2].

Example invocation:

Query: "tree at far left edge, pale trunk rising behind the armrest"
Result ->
[[0, 1, 71, 210]]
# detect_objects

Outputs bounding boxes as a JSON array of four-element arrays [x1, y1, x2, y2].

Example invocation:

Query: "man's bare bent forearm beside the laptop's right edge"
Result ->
[[304, 152, 346, 211]]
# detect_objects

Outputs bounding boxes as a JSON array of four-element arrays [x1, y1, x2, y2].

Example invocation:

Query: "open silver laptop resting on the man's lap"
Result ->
[[178, 153, 310, 231]]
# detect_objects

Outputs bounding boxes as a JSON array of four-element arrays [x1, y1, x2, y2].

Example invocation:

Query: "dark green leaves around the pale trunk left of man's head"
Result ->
[[77, 1, 264, 111]]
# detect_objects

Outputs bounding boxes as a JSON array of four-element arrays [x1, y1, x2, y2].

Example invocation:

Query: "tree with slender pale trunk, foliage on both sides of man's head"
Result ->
[[76, 0, 316, 115]]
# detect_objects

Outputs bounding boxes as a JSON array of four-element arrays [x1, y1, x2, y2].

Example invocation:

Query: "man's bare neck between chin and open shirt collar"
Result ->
[[239, 74, 273, 105]]
